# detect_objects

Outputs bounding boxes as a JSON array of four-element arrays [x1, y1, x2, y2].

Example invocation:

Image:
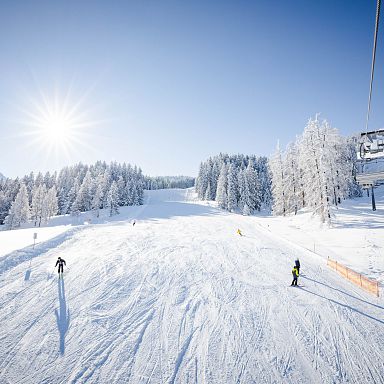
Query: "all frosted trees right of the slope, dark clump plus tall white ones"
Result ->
[[195, 116, 362, 222]]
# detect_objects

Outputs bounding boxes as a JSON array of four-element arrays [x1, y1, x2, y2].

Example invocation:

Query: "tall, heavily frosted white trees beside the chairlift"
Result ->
[[269, 116, 362, 222]]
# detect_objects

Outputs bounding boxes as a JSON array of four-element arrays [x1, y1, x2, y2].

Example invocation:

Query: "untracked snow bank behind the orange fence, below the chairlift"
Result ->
[[255, 186, 384, 284]]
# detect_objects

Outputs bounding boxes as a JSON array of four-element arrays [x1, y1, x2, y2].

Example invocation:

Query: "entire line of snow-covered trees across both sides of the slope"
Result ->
[[0, 116, 362, 229]]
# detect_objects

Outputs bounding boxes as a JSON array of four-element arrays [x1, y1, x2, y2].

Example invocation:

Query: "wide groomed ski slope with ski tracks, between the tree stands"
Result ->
[[0, 190, 384, 384]]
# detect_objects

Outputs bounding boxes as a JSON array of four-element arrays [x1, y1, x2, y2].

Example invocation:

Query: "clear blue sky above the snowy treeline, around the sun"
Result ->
[[0, 0, 384, 177]]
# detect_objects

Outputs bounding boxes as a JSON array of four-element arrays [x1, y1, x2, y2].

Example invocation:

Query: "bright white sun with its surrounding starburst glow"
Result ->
[[15, 83, 105, 168]]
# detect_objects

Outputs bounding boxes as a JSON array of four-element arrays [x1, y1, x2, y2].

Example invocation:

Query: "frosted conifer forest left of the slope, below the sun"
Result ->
[[0, 162, 145, 229]]
